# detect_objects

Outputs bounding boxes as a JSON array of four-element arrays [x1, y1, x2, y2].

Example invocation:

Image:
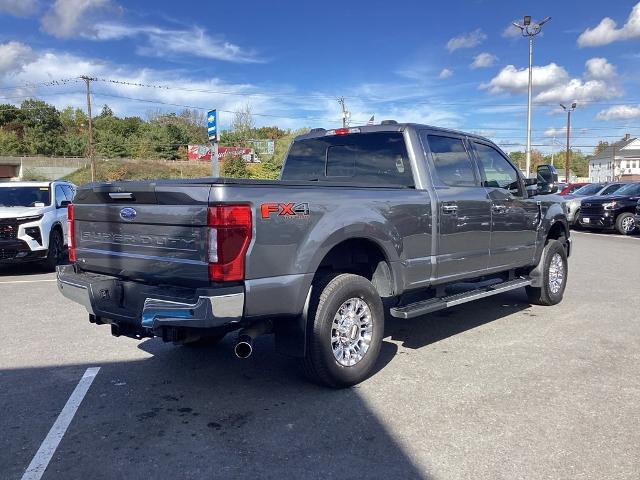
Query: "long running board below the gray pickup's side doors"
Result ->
[[391, 278, 531, 318]]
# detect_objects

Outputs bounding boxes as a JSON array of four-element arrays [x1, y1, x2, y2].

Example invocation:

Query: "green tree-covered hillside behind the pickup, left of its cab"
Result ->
[[0, 99, 305, 180]]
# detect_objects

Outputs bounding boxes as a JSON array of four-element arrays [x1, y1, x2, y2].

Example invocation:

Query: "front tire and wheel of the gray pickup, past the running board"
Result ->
[[526, 240, 569, 305]]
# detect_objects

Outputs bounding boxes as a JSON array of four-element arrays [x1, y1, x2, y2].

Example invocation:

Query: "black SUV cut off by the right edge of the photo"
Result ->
[[580, 182, 640, 235]]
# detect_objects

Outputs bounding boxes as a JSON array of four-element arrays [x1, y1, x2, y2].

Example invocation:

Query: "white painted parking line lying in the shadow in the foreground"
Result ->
[[22, 367, 100, 480]]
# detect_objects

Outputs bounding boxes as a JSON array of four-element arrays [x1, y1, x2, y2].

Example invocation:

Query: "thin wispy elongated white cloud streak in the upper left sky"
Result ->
[[88, 23, 263, 63]]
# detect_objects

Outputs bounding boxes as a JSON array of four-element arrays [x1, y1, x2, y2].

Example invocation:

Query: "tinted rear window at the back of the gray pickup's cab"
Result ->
[[282, 132, 414, 187]]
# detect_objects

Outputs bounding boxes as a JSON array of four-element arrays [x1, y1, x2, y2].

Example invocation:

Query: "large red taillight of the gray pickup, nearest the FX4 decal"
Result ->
[[207, 205, 251, 282]]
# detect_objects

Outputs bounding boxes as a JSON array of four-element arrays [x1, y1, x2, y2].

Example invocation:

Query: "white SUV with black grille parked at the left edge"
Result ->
[[0, 181, 76, 270]]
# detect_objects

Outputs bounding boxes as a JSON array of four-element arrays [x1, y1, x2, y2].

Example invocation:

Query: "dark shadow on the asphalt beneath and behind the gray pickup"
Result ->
[[0, 292, 529, 480]]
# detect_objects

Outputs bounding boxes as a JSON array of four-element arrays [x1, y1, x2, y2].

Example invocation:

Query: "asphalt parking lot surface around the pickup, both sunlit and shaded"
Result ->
[[0, 232, 640, 480]]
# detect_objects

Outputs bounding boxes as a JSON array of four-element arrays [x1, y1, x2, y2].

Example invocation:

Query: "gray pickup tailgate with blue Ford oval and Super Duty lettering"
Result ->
[[74, 182, 211, 286]]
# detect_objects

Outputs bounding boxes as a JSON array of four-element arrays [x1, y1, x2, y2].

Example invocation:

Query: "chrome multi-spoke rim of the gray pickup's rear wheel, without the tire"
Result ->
[[331, 298, 373, 367]]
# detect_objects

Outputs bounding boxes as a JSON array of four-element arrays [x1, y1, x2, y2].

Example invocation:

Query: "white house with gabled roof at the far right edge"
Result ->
[[589, 133, 640, 182]]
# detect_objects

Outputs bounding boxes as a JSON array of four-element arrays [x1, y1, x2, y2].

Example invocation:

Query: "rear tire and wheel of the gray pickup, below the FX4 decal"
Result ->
[[304, 274, 384, 388]]
